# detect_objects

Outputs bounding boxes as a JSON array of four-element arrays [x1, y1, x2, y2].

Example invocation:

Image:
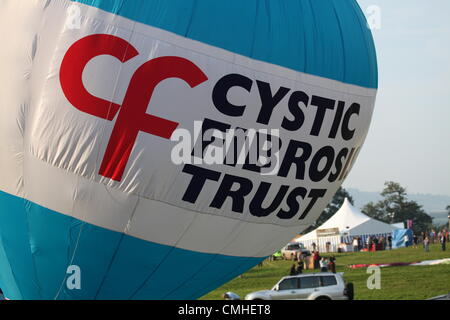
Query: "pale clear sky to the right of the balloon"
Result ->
[[344, 0, 450, 196]]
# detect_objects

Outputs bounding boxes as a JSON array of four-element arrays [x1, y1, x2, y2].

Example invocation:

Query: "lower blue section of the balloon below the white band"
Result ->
[[0, 192, 263, 300]]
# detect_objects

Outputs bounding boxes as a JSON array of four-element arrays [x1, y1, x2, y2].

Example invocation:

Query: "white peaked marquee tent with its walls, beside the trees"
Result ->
[[296, 199, 398, 252]]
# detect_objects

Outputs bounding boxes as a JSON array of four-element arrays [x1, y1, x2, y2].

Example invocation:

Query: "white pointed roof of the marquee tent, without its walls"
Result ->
[[299, 198, 396, 241]]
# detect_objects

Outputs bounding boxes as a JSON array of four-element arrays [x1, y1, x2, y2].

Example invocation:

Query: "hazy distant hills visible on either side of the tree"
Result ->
[[346, 188, 450, 224]]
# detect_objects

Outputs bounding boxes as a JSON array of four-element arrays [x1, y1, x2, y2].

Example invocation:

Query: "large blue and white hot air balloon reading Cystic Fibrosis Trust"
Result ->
[[0, 0, 377, 299]]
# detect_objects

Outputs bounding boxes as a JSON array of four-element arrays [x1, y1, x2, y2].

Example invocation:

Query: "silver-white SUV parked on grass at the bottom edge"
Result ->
[[245, 272, 353, 300]]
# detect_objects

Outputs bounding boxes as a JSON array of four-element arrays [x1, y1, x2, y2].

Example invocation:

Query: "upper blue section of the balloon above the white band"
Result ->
[[72, 0, 378, 88]]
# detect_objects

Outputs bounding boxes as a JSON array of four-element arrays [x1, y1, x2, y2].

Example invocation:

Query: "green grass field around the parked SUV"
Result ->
[[202, 245, 450, 300]]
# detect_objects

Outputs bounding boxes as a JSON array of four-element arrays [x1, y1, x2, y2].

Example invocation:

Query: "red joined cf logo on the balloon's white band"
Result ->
[[60, 34, 208, 181]]
